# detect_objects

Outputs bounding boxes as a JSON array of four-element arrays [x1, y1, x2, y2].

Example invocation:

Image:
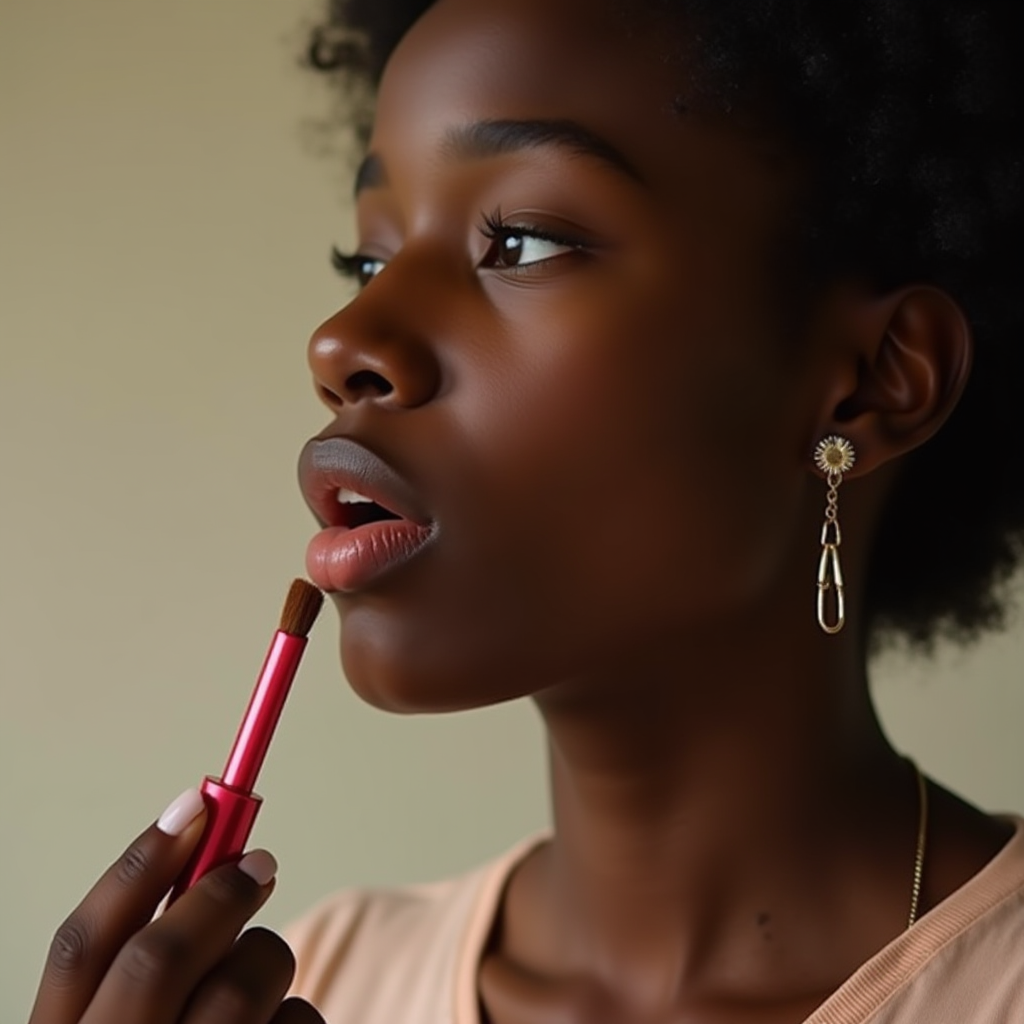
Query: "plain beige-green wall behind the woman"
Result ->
[[0, 0, 1024, 1024]]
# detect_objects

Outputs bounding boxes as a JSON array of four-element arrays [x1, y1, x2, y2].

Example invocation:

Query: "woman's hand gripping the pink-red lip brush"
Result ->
[[29, 790, 324, 1024]]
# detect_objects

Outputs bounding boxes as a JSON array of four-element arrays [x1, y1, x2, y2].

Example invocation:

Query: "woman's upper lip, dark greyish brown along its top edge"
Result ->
[[299, 437, 432, 526]]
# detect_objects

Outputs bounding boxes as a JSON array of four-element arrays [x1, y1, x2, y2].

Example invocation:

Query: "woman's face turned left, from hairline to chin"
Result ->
[[303, 0, 814, 710]]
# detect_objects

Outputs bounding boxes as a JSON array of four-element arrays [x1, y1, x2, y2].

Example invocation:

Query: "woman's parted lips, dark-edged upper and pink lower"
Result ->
[[299, 437, 437, 593]]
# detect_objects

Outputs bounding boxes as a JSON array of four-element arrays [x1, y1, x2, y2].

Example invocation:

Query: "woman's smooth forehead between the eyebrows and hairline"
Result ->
[[377, 0, 679, 165]]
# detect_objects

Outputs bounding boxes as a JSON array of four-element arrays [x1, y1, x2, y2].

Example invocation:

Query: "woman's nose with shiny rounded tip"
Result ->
[[309, 293, 441, 412]]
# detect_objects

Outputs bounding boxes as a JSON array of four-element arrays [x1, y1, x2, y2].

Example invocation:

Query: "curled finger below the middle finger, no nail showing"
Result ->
[[181, 928, 295, 1024]]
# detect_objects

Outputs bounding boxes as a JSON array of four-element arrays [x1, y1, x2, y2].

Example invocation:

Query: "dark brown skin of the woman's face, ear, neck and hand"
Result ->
[[32, 0, 1008, 1024]]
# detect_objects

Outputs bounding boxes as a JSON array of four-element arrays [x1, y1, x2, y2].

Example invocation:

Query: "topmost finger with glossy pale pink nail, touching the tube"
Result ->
[[29, 790, 205, 1024]]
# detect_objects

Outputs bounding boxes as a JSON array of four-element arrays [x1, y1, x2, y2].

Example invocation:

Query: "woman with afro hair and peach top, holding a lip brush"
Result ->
[[24, 0, 1024, 1024]]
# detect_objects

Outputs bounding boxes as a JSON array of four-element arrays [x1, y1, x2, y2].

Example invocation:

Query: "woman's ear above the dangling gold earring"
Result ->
[[819, 286, 973, 475]]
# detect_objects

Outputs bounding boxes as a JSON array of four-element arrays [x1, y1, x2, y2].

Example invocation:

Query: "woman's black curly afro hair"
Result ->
[[308, 0, 1024, 648]]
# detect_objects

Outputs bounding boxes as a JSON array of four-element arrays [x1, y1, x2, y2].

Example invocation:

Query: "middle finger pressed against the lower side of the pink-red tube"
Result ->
[[79, 850, 278, 1024]]
